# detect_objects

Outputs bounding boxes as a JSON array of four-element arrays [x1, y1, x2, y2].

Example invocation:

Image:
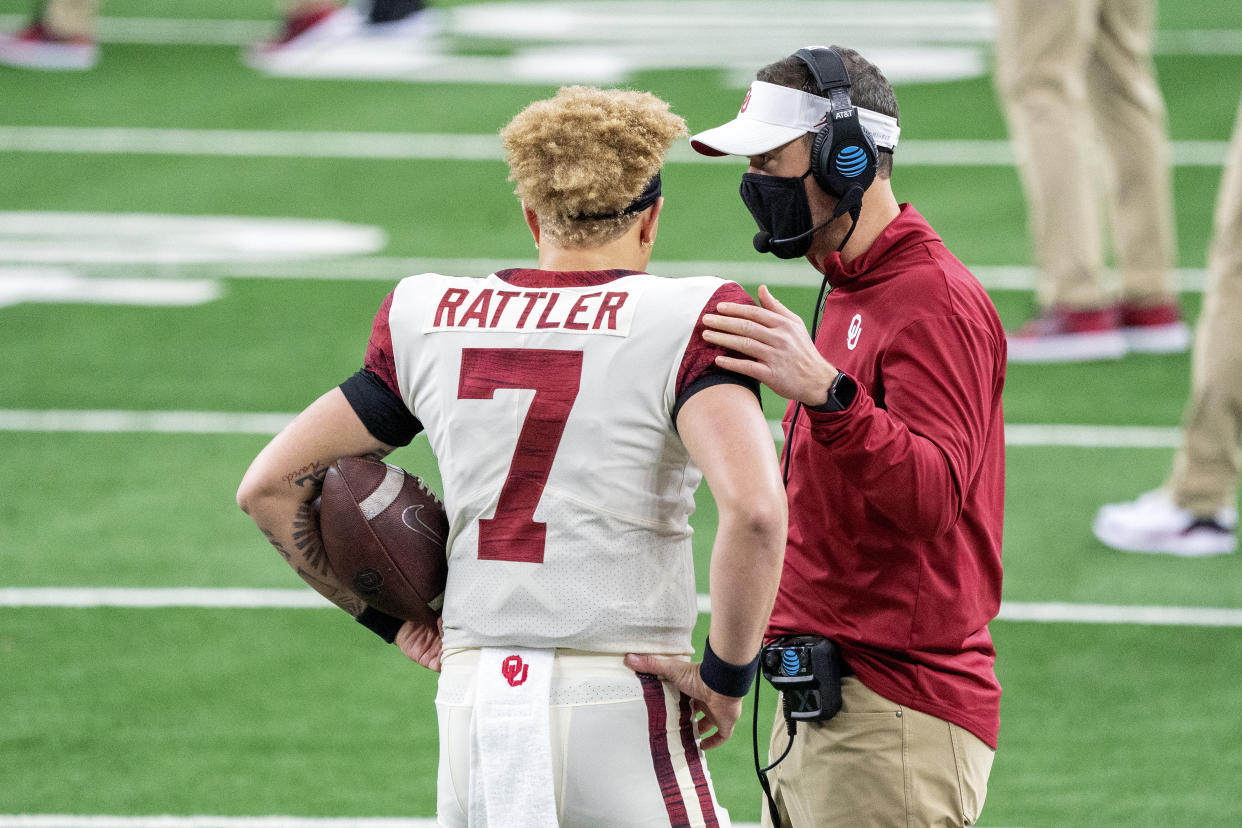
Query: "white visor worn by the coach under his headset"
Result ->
[[691, 81, 902, 155]]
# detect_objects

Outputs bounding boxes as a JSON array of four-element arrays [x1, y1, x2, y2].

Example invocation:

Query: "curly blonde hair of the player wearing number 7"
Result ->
[[501, 86, 687, 247]]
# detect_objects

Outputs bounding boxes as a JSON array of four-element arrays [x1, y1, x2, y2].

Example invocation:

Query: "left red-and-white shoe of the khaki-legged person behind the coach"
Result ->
[[1007, 308, 1126, 362]]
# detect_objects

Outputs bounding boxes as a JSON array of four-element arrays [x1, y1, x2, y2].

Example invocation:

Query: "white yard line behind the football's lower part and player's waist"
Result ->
[[0, 587, 1242, 627]]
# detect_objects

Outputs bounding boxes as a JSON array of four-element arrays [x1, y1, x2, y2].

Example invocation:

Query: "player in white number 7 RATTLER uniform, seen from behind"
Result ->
[[238, 87, 786, 828]]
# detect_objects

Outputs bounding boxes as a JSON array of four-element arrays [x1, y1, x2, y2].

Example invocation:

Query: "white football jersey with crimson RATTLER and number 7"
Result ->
[[377, 271, 749, 653]]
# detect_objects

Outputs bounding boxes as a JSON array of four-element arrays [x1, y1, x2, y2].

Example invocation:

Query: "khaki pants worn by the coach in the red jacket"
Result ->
[[763, 677, 994, 828]]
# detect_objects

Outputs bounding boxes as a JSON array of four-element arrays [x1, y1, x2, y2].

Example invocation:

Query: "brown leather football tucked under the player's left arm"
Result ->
[[319, 457, 448, 626]]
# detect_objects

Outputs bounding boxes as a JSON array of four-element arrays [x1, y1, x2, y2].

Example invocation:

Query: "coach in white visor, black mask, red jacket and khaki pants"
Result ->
[[692, 47, 1006, 827]]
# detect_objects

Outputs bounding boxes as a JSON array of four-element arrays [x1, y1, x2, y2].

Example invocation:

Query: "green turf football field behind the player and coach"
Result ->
[[0, 0, 1242, 828]]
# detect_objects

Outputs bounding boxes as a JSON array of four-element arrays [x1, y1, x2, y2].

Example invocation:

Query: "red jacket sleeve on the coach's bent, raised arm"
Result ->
[[806, 317, 1004, 539]]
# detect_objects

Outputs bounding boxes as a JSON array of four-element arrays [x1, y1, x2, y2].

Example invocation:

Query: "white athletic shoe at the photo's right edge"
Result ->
[[1092, 489, 1238, 557]]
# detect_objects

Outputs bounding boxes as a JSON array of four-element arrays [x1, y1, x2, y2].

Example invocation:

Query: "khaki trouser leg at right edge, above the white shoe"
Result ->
[[1166, 93, 1242, 515]]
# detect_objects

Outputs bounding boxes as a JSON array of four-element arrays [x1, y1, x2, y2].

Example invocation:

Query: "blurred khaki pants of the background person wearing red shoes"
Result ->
[[996, 0, 1176, 309]]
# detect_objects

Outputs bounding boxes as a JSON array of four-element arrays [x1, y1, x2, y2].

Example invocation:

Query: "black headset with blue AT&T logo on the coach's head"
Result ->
[[794, 47, 876, 216]]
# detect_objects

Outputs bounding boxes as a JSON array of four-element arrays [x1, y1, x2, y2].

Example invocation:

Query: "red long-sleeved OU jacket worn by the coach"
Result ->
[[769, 205, 1006, 749]]
